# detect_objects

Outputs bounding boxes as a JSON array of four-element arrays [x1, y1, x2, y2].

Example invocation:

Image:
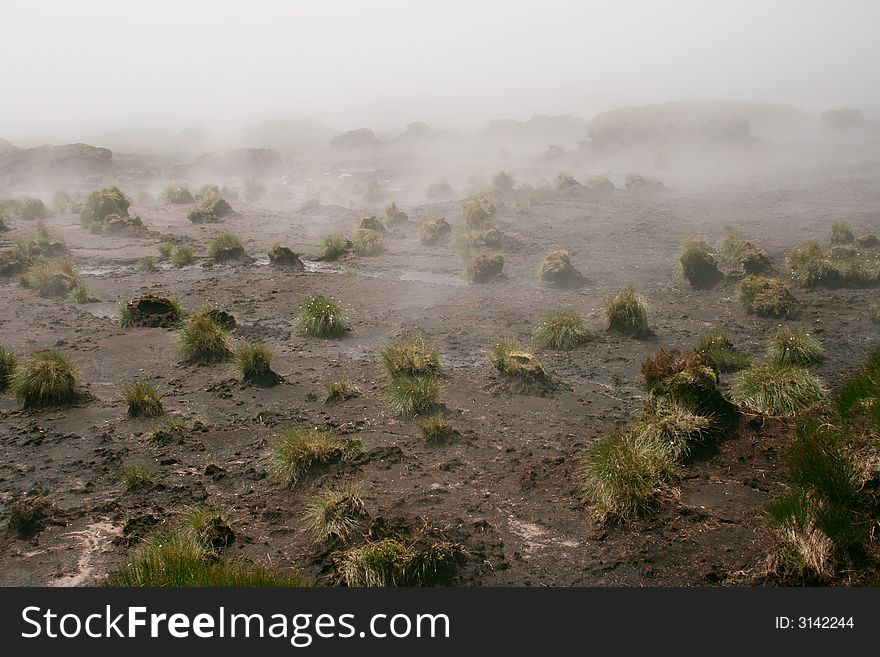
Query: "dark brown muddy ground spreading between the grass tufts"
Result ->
[[0, 154, 880, 586]]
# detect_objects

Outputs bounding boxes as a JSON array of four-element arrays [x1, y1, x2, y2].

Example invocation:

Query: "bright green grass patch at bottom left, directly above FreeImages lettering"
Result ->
[[103, 529, 305, 588]]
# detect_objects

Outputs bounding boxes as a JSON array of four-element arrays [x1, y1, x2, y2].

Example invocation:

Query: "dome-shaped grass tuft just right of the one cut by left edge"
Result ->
[[10, 349, 81, 408]]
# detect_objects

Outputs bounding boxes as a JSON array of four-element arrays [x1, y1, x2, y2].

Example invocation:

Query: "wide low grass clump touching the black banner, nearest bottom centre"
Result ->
[[333, 535, 463, 587]]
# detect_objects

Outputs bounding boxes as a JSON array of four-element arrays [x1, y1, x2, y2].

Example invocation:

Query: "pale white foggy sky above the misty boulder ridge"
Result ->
[[0, 0, 880, 141]]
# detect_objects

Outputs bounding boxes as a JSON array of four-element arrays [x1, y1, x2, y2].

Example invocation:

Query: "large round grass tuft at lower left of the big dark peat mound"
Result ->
[[579, 432, 675, 521]]
